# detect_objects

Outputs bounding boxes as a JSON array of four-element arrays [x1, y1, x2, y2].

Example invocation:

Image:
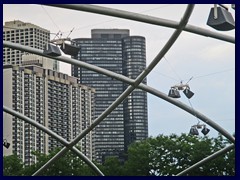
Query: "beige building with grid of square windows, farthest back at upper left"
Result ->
[[3, 20, 59, 71]]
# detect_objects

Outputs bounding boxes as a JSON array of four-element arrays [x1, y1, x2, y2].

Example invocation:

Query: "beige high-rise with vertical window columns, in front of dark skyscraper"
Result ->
[[3, 65, 95, 165]]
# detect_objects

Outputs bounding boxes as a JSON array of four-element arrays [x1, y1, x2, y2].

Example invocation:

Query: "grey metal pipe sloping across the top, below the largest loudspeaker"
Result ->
[[44, 4, 235, 44]]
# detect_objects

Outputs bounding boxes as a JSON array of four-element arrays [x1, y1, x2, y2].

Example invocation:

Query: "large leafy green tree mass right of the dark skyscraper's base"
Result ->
[[125, 134, 235, 176]]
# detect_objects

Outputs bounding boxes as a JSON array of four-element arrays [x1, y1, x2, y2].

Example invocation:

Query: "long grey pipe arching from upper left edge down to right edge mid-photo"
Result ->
[[3, 41, 235, 143]]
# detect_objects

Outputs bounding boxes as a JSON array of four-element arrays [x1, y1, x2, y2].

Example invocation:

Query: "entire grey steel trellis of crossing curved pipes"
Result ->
[[3, 5, 235, 175]]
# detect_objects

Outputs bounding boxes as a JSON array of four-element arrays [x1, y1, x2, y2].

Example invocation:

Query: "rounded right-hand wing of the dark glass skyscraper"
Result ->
[[122, 36, 148, 150]]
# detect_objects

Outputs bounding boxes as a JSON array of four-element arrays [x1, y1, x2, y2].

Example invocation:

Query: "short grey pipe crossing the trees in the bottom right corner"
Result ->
[[176, 144, 235, 176]]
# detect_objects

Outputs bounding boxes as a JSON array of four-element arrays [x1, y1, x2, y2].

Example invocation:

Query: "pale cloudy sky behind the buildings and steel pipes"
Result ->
[[3, 4, 235, 137]]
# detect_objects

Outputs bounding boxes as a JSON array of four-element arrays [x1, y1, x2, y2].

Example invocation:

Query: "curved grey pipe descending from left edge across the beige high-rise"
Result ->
[[3, 106, 104, 176]]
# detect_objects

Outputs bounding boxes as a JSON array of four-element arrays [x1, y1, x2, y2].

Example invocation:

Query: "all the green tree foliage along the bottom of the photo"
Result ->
[[3, 134, 235, 176]]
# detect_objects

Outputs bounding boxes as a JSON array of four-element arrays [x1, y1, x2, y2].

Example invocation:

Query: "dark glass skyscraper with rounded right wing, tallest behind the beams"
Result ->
[[72, 29, 148, 162]]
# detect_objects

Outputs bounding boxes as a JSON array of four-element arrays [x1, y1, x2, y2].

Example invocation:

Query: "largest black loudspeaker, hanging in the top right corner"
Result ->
[[207, 7, 235, 31]]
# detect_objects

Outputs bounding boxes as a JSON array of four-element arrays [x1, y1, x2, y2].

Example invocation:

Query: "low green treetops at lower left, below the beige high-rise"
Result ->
[[3, 149, 100, 176]]
